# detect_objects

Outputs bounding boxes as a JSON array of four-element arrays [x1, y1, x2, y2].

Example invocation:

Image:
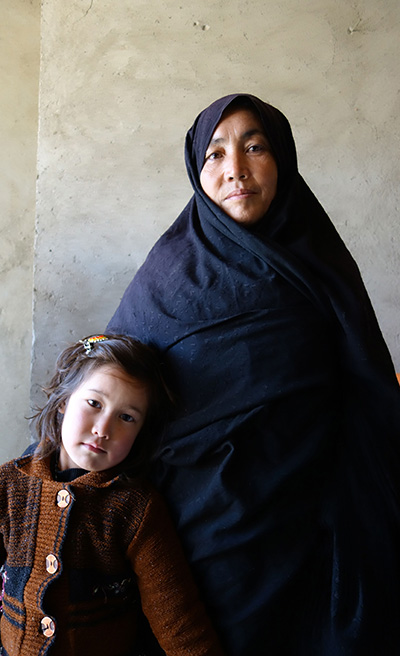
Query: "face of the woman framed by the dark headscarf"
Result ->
[[200, 109, 278, 225]]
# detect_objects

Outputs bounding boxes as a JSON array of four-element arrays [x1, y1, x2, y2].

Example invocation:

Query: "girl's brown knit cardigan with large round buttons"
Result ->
[[0, 456, 222, 656]]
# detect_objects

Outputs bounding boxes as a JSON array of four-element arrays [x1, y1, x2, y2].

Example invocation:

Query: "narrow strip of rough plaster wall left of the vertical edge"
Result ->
[[0, 0, 40, 462]]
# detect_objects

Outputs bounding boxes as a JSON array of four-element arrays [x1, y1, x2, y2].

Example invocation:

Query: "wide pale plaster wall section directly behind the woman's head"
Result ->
[[3, 0, 400, 462]]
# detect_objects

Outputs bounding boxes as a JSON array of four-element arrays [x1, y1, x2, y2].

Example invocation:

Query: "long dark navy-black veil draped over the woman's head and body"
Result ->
[[107, 95, 400, 656]]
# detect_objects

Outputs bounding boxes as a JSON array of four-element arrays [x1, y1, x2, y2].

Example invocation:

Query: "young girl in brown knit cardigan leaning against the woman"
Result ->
[[0, 335, 222, 656]]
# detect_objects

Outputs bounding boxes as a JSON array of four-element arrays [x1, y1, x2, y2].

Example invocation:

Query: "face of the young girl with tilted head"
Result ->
[[59, 365, 148, 471]]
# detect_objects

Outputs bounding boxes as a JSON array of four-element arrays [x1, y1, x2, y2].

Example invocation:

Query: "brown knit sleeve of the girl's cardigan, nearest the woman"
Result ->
[[128, 494, 223, 656]]
